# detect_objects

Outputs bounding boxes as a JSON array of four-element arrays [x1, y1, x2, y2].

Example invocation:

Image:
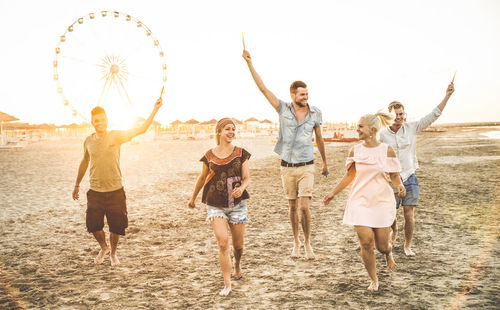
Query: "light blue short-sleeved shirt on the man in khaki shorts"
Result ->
[[274, 100, 323, 164]]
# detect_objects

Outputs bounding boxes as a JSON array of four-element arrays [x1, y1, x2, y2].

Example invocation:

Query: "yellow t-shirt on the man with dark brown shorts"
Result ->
[[83, 130, 131, 192]]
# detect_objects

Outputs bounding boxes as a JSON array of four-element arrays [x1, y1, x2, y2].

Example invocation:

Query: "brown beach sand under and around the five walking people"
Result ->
[[0, 128, 500, 309]]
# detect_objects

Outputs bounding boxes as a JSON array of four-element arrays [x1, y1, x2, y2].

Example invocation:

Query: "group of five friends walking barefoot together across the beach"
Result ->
[[73, 49, 454, 296]]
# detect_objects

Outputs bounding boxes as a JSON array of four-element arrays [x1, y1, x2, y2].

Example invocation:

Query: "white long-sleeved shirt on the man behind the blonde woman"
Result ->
[[380, 107, 441, 182]]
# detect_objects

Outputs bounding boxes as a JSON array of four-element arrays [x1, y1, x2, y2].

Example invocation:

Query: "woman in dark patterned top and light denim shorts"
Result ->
[[188, 118, 250, 296]]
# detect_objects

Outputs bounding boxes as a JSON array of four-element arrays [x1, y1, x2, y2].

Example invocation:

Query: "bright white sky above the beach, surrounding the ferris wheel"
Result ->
[[0, 0, 500, 124]]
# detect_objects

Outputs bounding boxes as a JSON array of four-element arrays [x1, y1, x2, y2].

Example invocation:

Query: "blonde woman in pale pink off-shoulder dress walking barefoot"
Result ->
[[323, 112, 405, 291]]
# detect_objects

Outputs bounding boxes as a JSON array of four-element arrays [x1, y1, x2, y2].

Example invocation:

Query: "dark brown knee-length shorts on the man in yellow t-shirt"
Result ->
[[86, 187, 128, 236]]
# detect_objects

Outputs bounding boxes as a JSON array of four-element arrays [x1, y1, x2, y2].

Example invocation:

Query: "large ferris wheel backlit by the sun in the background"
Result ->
[[53, 11, 167, 128]]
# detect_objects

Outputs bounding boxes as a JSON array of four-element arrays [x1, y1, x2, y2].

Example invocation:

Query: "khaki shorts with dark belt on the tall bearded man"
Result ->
[[280, 165, 314, 200]]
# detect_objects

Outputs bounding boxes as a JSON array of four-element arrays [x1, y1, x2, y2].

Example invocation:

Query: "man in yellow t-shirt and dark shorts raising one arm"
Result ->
[[73, 97, 162, 266]]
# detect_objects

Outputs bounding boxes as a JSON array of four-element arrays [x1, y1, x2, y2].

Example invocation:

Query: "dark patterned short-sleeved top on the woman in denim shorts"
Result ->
[[200, 146, 251, 208]]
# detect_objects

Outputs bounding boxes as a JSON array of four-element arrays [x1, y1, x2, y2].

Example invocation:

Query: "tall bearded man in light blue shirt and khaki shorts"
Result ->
[[243, 50, 328, 259]]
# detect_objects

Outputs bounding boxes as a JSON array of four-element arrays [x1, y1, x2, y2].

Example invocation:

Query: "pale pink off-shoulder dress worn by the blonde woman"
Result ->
[[342, 143, 401, 228]]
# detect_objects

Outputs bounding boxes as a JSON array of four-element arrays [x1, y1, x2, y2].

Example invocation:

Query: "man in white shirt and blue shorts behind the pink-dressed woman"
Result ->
[[380, 82, 455, 256]]
